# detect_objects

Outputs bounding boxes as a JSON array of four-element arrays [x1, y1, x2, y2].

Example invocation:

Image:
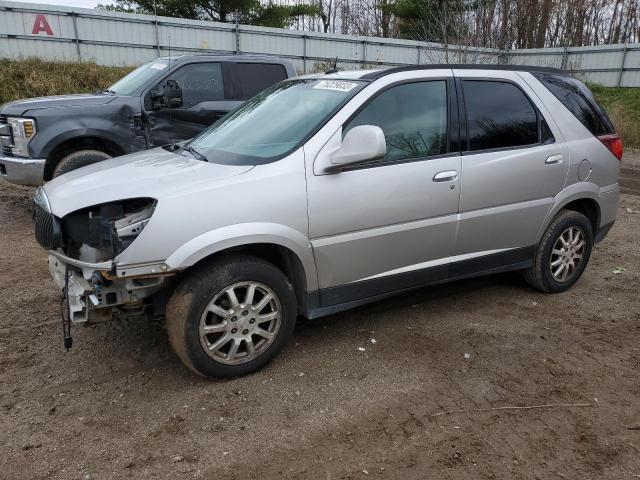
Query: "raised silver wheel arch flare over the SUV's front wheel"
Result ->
[[165, 223, 318, 292]]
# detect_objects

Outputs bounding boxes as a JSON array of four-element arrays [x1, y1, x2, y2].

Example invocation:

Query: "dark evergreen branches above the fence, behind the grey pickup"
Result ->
[[98, 0, 320, 28]]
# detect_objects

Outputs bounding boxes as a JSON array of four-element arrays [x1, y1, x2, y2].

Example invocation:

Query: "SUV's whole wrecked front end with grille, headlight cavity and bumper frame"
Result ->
[[33, 188, 171, 334]]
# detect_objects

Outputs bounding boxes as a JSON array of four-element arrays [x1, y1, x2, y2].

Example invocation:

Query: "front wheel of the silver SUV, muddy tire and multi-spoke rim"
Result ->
[[166, 255, 297, 378]]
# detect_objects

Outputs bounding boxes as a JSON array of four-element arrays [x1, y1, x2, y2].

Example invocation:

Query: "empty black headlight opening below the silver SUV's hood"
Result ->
[[62, 198, 156, 259]]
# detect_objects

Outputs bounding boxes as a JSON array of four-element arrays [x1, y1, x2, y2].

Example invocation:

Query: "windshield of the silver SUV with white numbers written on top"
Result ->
[[186, 79, 366, 165]]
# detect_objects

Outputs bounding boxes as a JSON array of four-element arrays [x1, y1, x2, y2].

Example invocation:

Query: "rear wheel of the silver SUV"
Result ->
[[524, 210, 593, 293]]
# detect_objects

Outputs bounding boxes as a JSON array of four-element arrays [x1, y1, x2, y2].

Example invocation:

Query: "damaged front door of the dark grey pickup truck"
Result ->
[[144, 62, 242, 148]]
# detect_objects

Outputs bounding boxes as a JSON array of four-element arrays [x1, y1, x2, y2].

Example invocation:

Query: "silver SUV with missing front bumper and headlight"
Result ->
[[34, 66, 622, 377]]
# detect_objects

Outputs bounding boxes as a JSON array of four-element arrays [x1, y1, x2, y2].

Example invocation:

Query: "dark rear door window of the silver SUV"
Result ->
[[463, 80, 539, 151]]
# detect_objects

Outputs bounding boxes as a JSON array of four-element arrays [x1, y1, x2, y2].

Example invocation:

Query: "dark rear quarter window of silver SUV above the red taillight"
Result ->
[[534, 73, 615, 136]]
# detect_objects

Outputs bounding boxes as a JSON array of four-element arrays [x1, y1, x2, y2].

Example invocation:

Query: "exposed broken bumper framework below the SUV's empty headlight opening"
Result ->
[[49, 250, 175, 323]]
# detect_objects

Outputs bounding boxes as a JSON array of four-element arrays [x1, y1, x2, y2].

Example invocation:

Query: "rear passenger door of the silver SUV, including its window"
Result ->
[[451, 70, 569, 270]]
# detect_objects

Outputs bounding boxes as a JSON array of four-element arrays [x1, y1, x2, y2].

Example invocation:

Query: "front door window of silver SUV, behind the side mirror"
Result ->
[[342, 80, 447, 162]]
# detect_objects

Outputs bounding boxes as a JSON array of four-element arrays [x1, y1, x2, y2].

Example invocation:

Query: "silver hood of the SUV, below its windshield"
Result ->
[[43, 148, 253, 218]]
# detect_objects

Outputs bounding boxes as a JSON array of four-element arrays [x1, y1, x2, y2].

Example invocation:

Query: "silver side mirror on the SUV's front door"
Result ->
[[327, 125, 387, 172]]
